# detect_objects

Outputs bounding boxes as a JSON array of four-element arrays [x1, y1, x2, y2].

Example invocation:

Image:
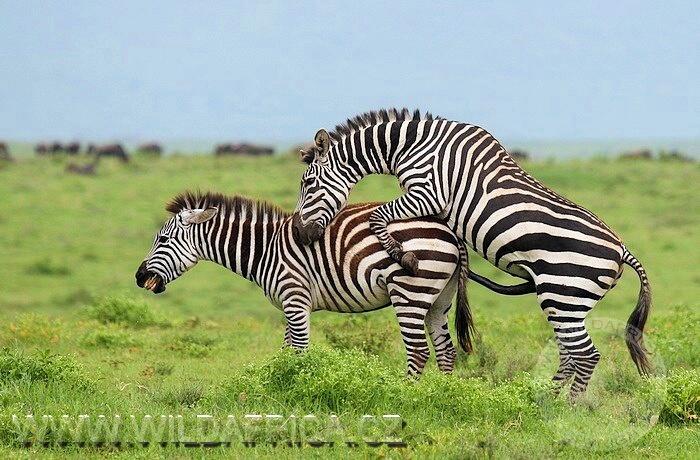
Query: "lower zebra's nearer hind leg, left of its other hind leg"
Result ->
[[390, 290, 430, 378]]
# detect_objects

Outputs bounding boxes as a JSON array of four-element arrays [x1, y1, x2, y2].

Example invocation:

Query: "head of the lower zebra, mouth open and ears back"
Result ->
[[136, 208, 218, 294]]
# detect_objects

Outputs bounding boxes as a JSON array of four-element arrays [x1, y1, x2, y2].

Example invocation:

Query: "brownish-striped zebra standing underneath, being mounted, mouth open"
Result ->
[[135, 192, 482, 377]]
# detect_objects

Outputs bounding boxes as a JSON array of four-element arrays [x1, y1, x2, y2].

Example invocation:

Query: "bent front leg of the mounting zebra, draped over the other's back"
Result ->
[[369, 188, 445, 275]]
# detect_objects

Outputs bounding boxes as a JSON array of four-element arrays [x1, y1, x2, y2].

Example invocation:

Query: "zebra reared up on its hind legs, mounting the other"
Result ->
[[295, 109, 651, 399]]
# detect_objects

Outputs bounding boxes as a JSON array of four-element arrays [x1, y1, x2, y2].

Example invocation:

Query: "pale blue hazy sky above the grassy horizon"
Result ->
[[0, 0, 700, 142]]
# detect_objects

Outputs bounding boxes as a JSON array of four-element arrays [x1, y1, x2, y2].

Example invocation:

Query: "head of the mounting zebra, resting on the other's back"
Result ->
[[293, 129, 357, 244]]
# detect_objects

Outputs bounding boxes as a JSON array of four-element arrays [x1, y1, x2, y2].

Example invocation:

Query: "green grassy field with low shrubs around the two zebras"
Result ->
[[0, 156, 700, 458]]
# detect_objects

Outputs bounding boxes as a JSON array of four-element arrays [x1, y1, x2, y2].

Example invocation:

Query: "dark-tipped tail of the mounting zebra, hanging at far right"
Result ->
[[622, 247, 651, 375]]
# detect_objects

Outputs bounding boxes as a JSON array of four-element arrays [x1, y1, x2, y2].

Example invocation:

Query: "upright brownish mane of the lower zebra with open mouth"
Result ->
[[165, 190, 290, 219]]
